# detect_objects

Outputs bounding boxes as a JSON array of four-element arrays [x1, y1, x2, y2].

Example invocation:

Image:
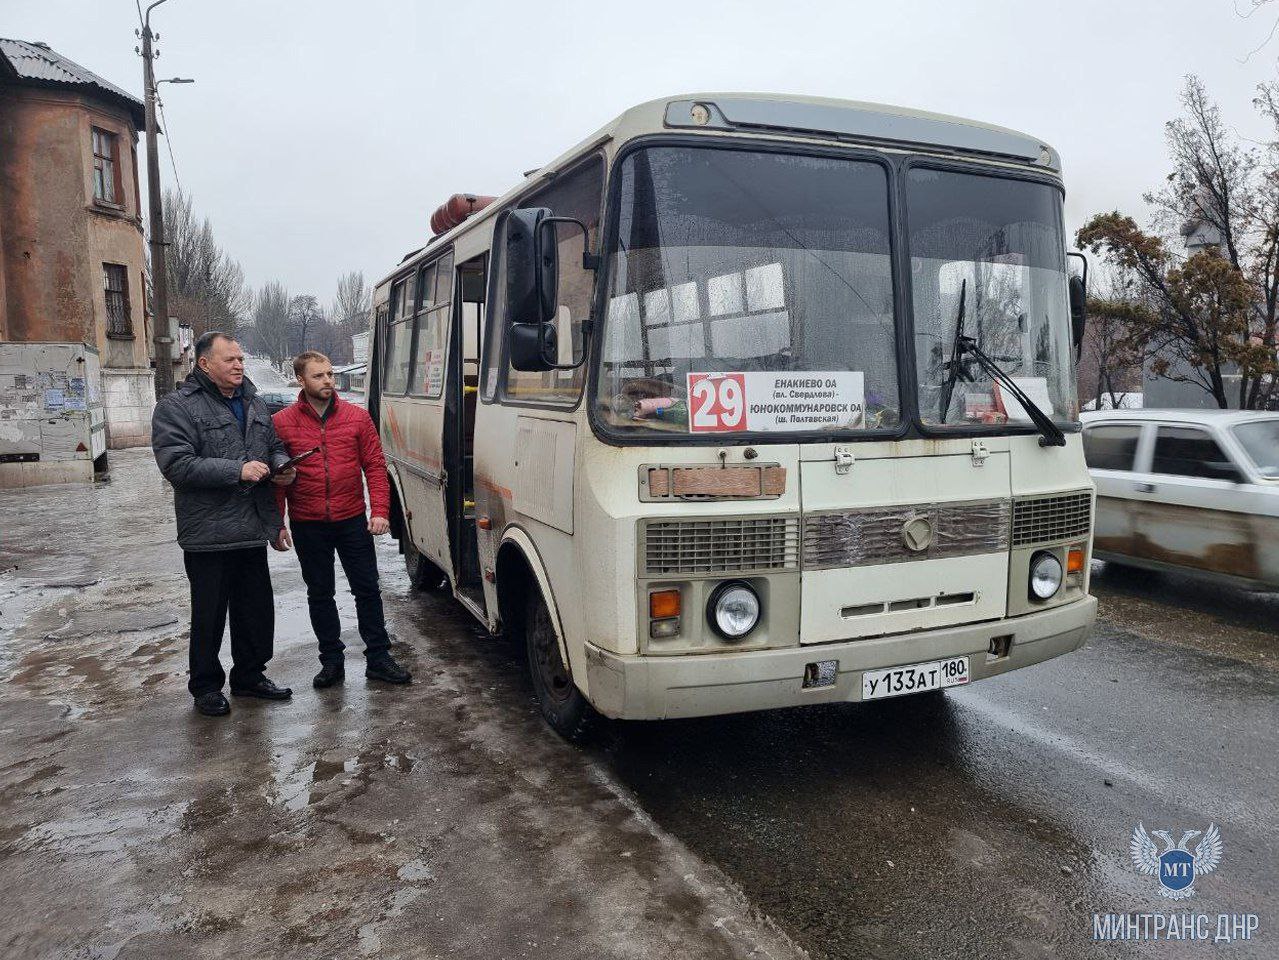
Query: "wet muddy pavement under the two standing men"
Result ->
[[0, 451, 798, 960]]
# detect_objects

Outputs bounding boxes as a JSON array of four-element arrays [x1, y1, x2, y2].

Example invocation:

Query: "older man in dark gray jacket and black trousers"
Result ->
[[151, 331, 295, 717]]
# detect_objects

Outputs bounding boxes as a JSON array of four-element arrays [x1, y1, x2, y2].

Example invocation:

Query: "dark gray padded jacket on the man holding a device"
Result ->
[[151, 369, 289, 552]]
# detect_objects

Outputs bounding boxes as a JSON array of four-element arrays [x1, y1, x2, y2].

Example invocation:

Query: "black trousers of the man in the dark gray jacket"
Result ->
[[182, 546, 275, 697]]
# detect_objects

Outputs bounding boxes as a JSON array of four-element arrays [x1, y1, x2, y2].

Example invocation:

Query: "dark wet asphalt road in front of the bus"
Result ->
[[606, 579, 1279, 957]]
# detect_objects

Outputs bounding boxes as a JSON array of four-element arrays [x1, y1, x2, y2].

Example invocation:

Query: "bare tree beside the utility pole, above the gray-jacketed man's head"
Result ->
[[164, 190, 252, 336]]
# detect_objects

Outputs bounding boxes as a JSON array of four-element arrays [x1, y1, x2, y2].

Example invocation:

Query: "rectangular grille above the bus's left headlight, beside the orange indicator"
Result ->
[[641, 516, 799, 577]]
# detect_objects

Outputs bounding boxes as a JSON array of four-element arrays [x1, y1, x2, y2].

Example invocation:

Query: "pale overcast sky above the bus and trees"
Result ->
[[7, 0, 1279, 303]]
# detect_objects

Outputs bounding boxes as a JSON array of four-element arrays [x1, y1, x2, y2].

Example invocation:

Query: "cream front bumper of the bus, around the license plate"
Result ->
[[586, 597, 1097, 720]]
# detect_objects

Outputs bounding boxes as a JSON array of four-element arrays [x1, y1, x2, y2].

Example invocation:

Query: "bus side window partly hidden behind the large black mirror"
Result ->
[[494, 159, 604, 404]]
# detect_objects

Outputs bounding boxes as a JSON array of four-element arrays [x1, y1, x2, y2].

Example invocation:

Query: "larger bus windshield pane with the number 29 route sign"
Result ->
[[595, 147, 900, 435]]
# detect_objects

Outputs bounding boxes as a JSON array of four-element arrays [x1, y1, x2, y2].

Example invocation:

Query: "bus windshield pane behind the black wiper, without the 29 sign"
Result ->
[[906, 167, 1078, 426]]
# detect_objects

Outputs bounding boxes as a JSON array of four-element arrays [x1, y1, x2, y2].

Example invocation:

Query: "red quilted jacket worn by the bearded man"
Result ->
[[271, 392, 391, 520]]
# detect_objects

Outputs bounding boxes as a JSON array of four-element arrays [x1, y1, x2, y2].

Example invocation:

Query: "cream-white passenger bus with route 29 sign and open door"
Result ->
[[368, 93, 1096, 739]]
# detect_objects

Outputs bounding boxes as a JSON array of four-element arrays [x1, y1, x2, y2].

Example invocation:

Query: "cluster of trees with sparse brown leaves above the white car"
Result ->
[[1076, 77, 1279, 409]]
